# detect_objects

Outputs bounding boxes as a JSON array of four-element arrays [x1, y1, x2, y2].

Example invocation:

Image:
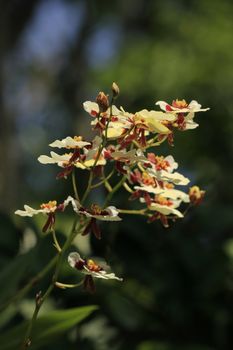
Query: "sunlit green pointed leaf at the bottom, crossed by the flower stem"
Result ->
[[0, 305, 98, 350]]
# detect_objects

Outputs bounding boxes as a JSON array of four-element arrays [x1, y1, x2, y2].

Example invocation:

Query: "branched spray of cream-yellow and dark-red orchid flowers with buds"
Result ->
[[16, 83, 209, 291]]
